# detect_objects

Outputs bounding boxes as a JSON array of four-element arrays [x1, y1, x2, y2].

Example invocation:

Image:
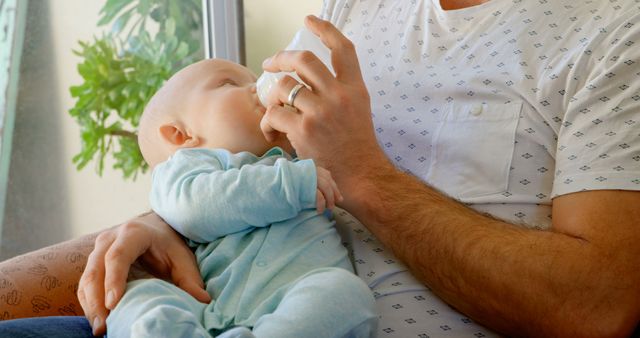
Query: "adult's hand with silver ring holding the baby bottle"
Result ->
[[261, 16, 389, 199]]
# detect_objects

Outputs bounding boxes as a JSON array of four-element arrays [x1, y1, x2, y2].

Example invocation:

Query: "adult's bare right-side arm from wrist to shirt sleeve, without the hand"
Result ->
[[341, 163, 640, 337]]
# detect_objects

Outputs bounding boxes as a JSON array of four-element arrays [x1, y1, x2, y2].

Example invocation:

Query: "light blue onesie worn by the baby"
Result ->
[[107, 148, 377, 338]]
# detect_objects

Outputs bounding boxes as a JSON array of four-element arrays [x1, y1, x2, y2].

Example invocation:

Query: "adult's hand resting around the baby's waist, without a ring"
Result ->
[[78, 213, 211, 335]]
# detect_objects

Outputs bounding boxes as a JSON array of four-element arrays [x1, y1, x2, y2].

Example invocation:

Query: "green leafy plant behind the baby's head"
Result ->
[[69, 0, 202, 179]]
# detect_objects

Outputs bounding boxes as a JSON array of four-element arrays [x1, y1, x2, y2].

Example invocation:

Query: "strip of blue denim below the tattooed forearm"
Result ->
[[0, 317, 93, 338]]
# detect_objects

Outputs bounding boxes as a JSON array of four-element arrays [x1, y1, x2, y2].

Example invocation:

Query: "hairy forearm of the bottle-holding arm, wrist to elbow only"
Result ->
[[341, 164, 635, 336]]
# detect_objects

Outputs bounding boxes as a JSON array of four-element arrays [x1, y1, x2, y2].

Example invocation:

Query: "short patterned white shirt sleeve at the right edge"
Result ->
[[552, 15, 640, 197]]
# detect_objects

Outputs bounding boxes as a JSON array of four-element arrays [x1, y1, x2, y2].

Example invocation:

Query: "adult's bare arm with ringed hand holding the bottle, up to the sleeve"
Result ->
[[263, 18, 640, 337]]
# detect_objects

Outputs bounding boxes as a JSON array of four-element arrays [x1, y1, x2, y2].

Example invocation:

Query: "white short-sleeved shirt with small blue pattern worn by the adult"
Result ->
[[322, 0, 640, 337]]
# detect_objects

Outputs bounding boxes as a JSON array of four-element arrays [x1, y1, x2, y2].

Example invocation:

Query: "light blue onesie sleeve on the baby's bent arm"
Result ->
[[150, 149, 317, 242]]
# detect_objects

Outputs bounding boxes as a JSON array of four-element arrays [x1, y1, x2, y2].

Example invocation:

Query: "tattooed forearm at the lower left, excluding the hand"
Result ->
[[0, 228, 97, 320]]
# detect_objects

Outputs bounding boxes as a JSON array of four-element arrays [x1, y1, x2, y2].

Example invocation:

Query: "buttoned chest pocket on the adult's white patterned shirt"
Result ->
[[426, 101, 522, 203]]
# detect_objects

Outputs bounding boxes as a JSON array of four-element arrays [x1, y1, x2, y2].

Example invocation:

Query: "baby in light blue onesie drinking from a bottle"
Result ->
[[102, 60, 377, 338]]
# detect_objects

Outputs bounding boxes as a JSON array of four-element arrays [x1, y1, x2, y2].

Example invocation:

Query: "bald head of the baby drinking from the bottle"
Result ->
[[138, 59, 292, 168]]
